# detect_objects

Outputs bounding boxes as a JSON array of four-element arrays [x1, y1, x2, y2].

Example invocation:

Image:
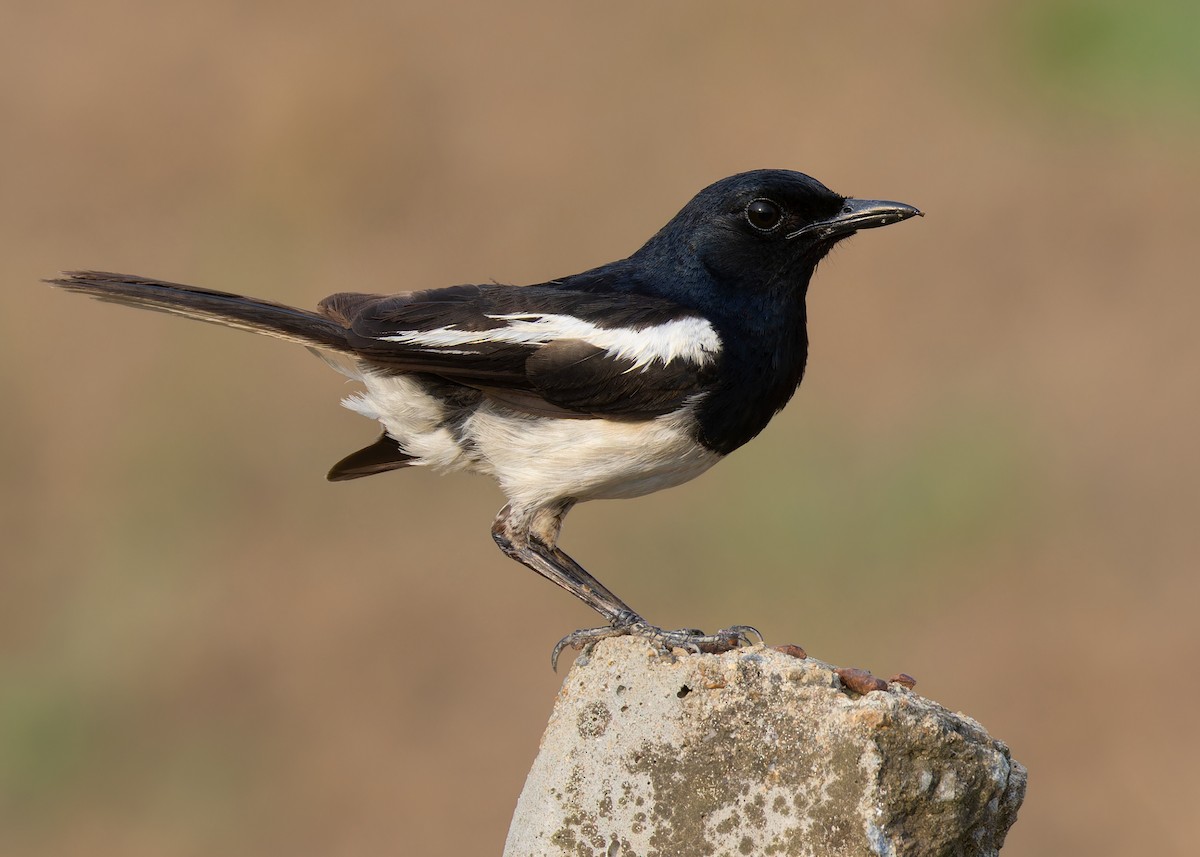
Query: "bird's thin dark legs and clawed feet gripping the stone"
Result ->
[[492, 501, 762, 669]]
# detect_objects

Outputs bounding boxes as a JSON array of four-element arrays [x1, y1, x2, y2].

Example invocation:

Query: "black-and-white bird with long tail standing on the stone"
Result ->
[[46, 169, 923, 669]]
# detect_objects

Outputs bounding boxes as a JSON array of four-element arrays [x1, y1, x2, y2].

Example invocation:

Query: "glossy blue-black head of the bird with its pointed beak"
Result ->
[[636, 169, 920, 309]]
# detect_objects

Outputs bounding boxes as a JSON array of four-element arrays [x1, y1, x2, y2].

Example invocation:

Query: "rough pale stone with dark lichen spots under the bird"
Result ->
[[504, 637, 1026, 857]]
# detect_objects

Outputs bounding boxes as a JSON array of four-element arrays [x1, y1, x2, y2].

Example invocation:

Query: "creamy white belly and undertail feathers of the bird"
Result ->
[[342, 374, 720, 508]]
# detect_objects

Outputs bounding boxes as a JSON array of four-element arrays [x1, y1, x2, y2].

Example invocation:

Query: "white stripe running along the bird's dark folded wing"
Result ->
[[379, 312, 721, 371]]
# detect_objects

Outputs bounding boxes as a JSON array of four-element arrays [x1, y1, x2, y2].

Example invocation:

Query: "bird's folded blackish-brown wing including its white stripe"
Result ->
[[322, 286, 721, 419]]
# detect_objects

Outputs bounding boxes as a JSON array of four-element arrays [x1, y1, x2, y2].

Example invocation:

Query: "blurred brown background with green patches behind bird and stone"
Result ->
[[0, 0, 1200, 857]]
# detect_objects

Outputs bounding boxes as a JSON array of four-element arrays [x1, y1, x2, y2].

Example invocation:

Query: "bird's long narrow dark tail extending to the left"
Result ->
[[46, 271, 350, 352]]
